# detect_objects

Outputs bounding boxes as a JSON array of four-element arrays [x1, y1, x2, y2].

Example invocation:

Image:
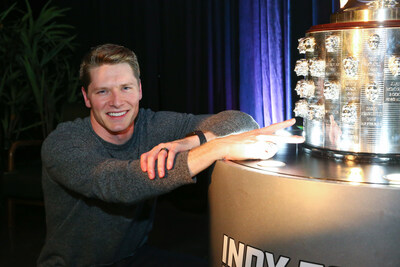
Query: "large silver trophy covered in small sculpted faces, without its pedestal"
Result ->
[[294, 0, 400, 161]]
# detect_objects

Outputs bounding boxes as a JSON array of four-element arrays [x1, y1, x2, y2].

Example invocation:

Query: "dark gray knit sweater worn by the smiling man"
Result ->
[[38, 109, 258, 267]]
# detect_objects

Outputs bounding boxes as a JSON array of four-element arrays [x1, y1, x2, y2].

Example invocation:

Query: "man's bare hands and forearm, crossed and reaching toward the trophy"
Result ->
[[141, 119, 304, 179]]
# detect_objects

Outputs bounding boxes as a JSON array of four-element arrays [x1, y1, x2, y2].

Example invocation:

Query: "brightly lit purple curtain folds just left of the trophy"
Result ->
[[239, 0, 290, 126]]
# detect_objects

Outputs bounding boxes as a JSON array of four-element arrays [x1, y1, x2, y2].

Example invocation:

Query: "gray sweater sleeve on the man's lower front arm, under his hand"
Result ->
[[42, 132, 195, 204]]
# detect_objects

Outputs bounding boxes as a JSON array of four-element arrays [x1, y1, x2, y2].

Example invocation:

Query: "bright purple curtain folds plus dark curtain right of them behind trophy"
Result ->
[[238, 0, 339, 126]]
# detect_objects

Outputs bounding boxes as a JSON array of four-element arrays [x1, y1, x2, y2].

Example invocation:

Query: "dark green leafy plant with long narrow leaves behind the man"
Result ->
[[0, 0, 79, 153]]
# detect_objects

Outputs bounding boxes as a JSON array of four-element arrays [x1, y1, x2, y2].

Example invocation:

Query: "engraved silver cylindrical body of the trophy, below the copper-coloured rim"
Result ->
[[296, 25, 400, 155]]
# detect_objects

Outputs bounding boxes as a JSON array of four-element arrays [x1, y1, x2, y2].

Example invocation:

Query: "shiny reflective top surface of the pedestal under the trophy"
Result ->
[[235, 144, 400, 187]]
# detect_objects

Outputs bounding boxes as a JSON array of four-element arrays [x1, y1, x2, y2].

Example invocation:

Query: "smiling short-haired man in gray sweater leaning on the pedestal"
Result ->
[[38, 44, 303, 266]]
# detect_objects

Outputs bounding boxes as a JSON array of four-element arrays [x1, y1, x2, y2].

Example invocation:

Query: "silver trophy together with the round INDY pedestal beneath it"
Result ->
[[208, 0, 400, 267]]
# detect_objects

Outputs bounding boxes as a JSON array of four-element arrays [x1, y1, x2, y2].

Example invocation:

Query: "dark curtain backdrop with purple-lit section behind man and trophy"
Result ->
[[25, 0, 339, 126]]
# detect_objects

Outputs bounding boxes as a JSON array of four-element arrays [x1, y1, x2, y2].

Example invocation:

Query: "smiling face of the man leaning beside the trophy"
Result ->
[[82, 63, 142, 144]]
